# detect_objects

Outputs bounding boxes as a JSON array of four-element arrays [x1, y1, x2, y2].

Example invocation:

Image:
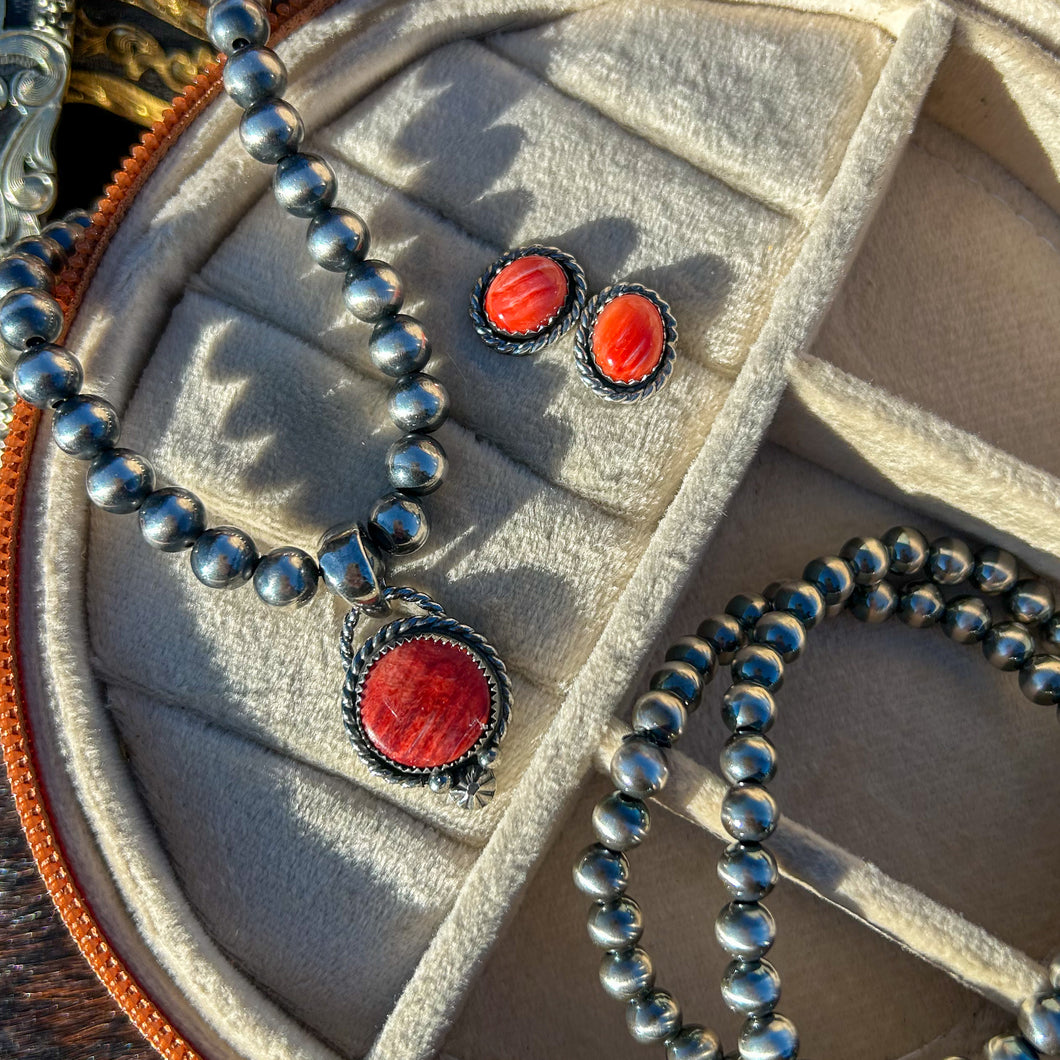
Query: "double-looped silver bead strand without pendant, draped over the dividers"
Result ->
[[573, 527, 1060, 1060]]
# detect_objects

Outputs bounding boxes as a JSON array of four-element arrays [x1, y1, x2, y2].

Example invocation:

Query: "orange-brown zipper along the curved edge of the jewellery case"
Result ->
[[0, 0, 334, 1060]]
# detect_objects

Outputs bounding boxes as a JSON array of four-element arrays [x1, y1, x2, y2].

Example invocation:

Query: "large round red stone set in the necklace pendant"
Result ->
[[360, 637, 492, 769]]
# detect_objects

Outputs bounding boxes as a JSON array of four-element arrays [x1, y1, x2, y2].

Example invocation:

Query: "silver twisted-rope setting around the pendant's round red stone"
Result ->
[[340, 587, 512, 810]]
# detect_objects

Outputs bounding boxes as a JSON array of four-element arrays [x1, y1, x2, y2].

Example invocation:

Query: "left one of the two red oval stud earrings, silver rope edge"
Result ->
[[471, 245, 585, 356]]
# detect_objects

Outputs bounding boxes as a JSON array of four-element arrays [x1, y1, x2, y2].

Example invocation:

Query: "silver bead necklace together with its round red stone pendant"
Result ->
[[0, 0, 511, 809]]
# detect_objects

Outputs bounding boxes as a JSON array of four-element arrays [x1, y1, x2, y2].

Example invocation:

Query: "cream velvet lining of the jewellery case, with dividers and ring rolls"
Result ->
[[14, 0, 1060, 1060]]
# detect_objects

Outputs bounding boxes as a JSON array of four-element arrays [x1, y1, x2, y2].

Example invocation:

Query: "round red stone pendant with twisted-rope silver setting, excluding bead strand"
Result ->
[[342, 589, 511, 809]]
